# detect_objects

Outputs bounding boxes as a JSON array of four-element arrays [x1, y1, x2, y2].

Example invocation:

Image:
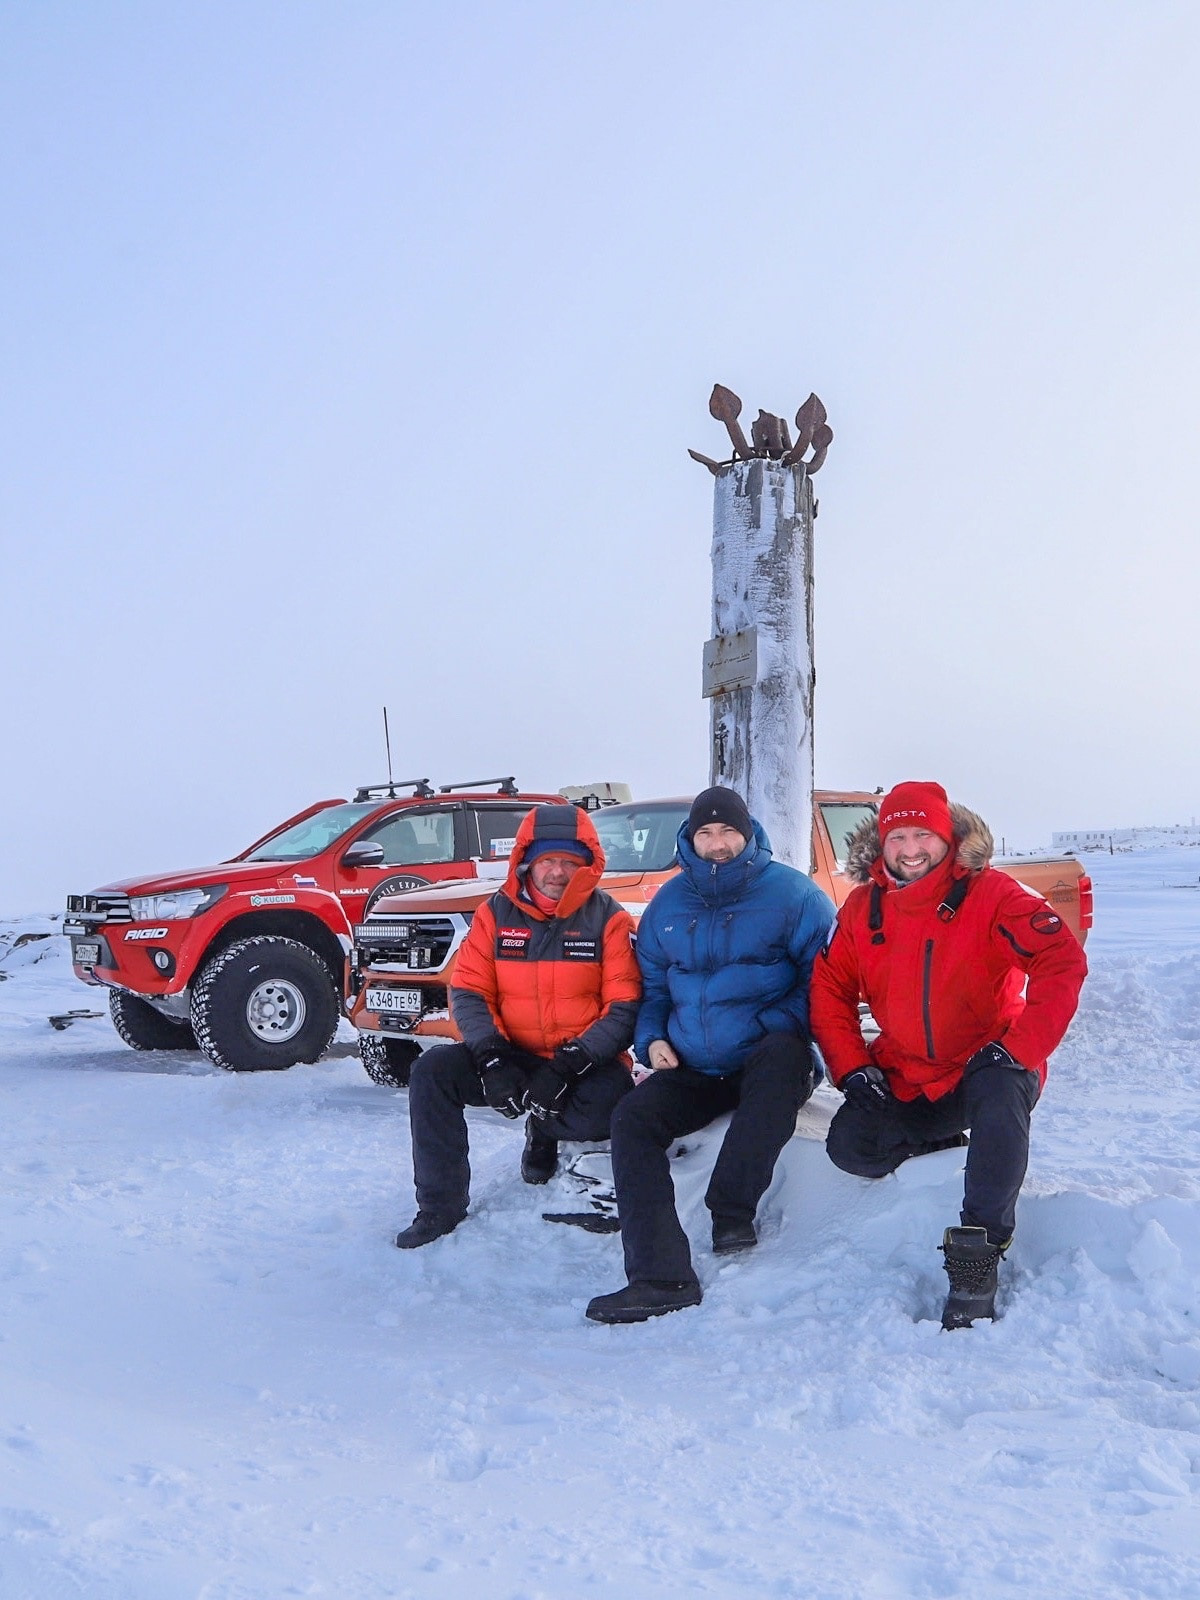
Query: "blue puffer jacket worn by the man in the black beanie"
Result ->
[[634, 822, 834, 1077]]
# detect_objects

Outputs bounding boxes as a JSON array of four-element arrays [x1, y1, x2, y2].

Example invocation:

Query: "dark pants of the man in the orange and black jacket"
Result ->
[[408, 1045, 634, 1218]]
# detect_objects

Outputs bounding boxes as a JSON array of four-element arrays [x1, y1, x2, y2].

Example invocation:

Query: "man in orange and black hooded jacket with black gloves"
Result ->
[[395, 805, 642, 1250]]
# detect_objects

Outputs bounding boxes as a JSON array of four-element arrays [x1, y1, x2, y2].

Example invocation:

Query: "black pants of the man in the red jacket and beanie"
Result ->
[[826, 1067, 1040, 1245]]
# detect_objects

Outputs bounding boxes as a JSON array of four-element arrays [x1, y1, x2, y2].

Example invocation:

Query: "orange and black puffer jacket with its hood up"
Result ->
[[450, 805, 642, 1061]]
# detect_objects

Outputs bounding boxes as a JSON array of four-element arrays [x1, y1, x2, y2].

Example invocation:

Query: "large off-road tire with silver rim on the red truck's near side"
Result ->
[[192, 934, 341, 1072]]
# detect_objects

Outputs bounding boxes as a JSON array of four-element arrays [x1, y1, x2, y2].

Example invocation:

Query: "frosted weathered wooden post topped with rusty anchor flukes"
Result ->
[[688, 384, 834, 872]]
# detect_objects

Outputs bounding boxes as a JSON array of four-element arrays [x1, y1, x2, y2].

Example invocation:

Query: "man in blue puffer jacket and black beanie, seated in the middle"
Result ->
[[587, 787, 834, 1322]]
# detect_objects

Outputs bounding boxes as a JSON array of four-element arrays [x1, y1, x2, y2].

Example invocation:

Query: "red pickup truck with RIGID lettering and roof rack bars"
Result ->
[[64, 778, 562, 1072]]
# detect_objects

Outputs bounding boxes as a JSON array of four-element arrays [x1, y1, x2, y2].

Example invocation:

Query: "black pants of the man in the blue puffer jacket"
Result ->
[[613, 1034, 816, 1283]]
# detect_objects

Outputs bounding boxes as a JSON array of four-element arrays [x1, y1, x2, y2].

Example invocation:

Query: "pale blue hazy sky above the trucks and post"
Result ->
[[0, 0, 1200, 910]]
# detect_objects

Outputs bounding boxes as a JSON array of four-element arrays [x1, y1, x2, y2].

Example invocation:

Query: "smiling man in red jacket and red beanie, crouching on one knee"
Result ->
[[810, 782, 1088, 1328]]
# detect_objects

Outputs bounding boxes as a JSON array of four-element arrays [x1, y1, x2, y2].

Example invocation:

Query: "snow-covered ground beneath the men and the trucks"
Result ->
[[0, 850, 1200, 1600]]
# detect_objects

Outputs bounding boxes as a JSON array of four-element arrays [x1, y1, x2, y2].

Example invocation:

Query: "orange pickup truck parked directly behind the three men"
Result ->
[[346, 789, 1091, 1083]]
